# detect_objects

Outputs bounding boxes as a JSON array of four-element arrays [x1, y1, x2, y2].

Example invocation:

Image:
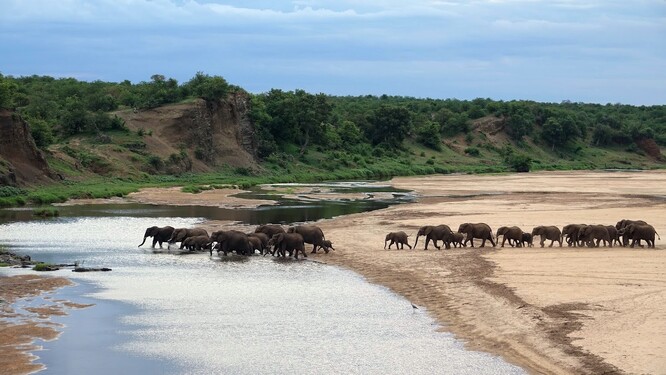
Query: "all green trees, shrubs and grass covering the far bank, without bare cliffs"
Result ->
[[0, 72, 666, 207]]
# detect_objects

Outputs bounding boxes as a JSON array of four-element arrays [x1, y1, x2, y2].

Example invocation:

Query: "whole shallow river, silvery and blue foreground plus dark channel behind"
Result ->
[[0, 184, 524, 375]]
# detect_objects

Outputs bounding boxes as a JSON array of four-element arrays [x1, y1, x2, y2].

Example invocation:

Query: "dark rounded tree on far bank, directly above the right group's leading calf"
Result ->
[[368, 104, 412, 147]]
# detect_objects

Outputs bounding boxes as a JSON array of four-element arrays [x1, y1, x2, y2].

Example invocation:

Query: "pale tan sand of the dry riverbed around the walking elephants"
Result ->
[[2, 171, 666, 374]]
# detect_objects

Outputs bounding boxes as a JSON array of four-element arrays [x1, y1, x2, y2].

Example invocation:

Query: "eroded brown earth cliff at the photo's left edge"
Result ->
[[0, 109, 54, 185]]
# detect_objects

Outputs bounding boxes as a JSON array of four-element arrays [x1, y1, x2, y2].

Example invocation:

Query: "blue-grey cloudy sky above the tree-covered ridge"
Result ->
[[0, 0, 666, 105]]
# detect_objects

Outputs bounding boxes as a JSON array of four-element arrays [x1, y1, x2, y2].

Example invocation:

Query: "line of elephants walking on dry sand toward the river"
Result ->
[[384, 219, 661, 250]]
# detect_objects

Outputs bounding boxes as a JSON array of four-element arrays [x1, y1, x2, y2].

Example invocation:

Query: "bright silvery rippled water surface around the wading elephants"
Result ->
[[0, 217, 524, 374]]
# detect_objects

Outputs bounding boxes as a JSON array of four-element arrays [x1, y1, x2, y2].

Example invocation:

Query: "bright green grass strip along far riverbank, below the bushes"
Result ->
[[0, 143, 663, 207]]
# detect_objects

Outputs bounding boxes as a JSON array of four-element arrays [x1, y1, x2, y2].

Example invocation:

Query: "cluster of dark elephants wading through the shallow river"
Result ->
[[139, 224, 335, 259]]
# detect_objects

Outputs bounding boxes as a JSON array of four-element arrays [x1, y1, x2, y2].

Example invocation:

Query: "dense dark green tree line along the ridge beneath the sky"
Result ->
[[0, 72, 666, 162]]
